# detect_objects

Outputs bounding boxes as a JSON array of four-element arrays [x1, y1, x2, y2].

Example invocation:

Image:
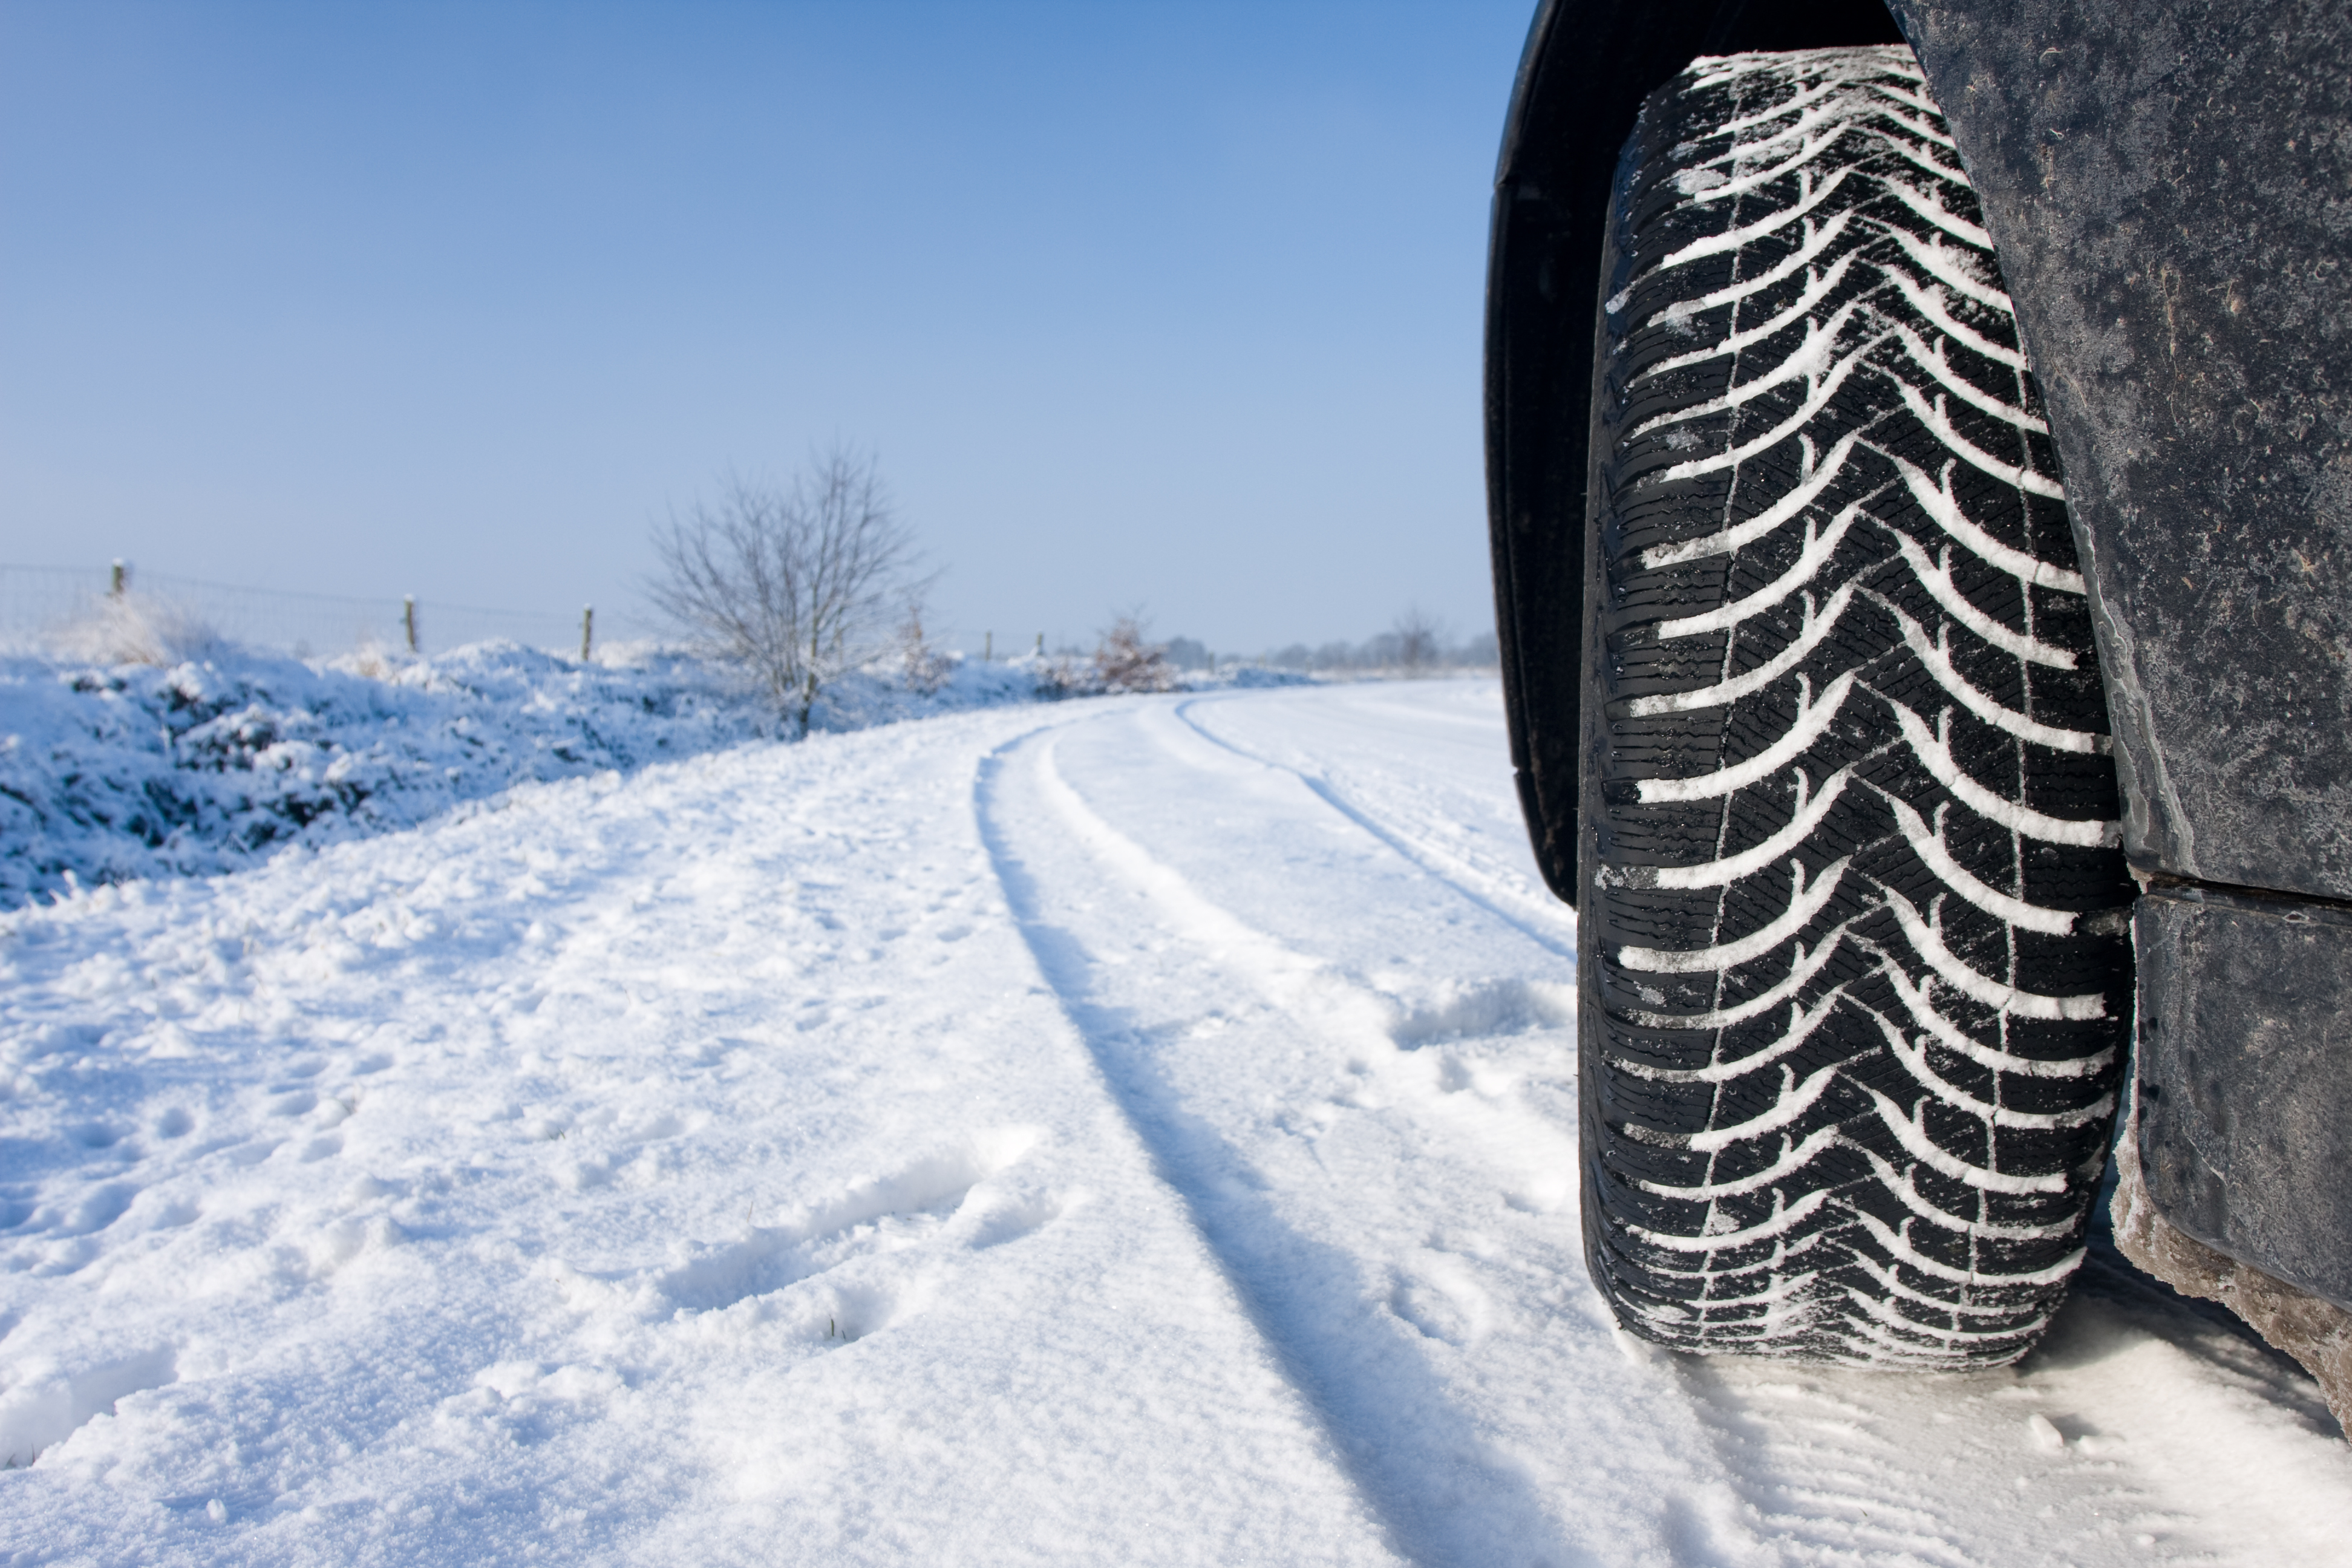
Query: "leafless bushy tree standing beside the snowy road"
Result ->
[[647, 446, 924, 733]]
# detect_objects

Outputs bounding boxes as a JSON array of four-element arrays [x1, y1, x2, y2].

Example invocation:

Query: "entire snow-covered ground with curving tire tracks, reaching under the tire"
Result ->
[[0, 682, 2352, 1566]]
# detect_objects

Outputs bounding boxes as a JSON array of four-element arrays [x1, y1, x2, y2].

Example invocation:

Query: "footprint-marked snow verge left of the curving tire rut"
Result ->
[[0, 714, 1367, 1561]]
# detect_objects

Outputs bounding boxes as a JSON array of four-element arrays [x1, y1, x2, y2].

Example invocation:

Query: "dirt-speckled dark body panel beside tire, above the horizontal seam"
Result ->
[[1898, 0, 2352, 900]]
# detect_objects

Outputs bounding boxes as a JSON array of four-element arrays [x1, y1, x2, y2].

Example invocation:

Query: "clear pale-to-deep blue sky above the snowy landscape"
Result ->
[[0, 0, 1534, 649]]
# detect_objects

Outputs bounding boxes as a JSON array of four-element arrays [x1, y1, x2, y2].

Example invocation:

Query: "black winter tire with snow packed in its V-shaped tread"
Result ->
[[1578, 47, 2131, 1368]]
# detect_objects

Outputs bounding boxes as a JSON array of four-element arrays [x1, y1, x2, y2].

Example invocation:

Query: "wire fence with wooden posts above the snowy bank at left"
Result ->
[[0, 564, 661, 658]]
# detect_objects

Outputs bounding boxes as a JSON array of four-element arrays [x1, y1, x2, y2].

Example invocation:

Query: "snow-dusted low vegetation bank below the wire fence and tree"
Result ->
[[0, 623, 1279, 907]]
